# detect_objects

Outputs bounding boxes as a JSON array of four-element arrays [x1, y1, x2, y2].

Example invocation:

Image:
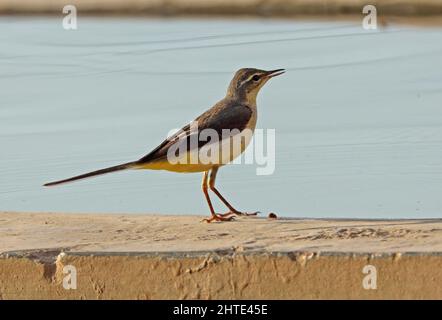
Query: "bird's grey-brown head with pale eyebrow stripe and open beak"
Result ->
[[227, 68, 285, 103]]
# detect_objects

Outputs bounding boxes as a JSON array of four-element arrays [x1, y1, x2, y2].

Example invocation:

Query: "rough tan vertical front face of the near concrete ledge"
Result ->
[[0, 251, 442, 299]]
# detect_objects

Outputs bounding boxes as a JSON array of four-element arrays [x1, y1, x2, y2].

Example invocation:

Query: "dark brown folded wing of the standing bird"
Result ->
[[137, 103, 252, 164]]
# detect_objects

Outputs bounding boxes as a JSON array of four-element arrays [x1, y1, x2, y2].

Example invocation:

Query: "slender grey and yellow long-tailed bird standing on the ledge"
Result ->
[[44, 68, 285, 223]]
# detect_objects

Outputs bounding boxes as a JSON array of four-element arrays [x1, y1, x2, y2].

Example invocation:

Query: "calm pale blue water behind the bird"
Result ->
[[0, 17, 442, 218]]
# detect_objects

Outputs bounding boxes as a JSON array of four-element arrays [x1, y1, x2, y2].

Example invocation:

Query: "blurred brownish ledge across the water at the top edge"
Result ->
[[0, 0, 442, 17]]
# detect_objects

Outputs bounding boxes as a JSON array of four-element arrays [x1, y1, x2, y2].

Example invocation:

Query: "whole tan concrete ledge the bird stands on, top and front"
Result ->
[[0, 212, 442, 299]]
